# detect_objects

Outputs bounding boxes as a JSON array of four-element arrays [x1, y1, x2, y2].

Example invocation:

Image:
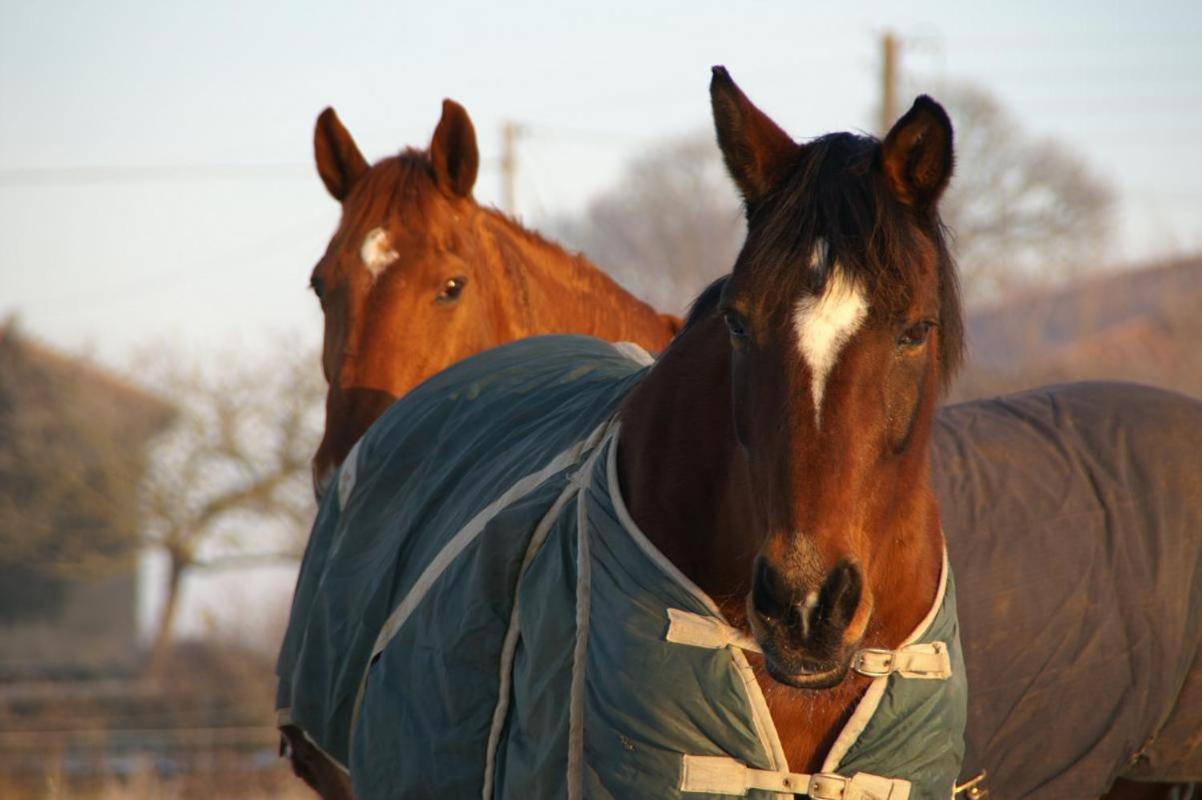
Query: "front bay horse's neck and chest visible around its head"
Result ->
[[618, 317, 942, 772]]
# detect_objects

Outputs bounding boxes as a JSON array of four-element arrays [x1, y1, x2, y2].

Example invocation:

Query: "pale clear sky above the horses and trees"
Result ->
[[0, 0, 1202, 366]]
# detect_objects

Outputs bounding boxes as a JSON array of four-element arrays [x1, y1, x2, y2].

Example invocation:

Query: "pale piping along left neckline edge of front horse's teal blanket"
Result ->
[[606, 428, 789, 783]]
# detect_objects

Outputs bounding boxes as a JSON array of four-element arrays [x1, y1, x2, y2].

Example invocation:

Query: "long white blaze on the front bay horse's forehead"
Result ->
[[793, 265, 868, 426]]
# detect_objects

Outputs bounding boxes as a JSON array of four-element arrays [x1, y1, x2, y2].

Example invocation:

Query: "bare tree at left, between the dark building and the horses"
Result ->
[[142, 338, 325, 664]]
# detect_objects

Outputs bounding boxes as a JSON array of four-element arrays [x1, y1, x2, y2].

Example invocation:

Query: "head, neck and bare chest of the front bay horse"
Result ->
[[286, 67, 963, 796]]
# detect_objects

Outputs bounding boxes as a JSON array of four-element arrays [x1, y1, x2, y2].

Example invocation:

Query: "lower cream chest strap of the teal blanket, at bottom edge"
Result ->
[[680, 756, 910, 800]]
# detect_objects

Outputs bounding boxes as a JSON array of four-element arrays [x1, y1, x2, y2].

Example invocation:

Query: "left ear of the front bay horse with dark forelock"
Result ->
[[709, 66, 801, 213]]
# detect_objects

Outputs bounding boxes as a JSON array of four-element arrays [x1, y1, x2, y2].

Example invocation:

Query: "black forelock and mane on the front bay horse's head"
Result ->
[[739, 133, 964, 387]]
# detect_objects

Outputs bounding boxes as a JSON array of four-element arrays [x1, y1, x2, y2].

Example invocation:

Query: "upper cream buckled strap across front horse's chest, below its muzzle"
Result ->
[[664, 608, 952, 680]]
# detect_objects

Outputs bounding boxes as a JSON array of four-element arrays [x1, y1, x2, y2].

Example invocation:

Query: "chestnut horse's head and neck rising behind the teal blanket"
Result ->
[[310, 100, 679, 494]]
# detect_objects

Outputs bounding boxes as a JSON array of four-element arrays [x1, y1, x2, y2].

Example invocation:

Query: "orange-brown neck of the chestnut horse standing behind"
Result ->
[[480, 210, 679, 351]]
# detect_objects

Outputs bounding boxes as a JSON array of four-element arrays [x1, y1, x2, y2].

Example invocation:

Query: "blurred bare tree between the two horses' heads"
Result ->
[[548, 133, 745, 312]]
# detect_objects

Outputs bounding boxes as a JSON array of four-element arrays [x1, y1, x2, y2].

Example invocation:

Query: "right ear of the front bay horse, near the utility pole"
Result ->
[[881, 95, 953, 209]]
